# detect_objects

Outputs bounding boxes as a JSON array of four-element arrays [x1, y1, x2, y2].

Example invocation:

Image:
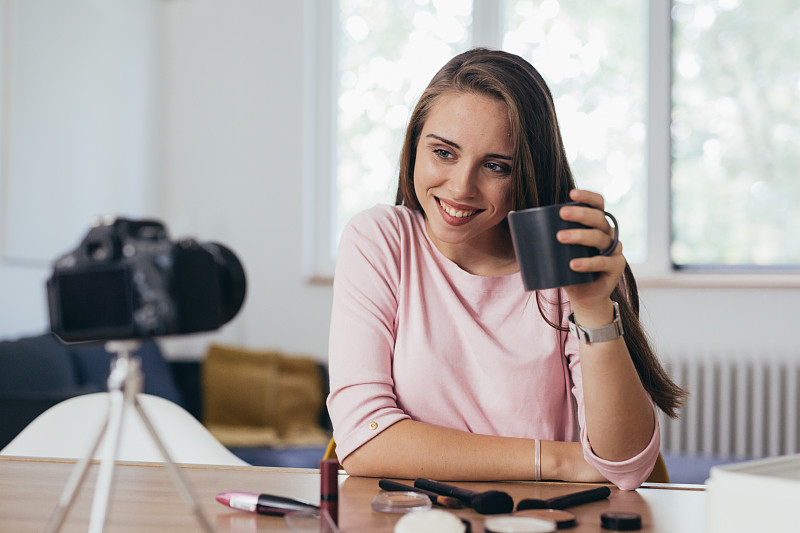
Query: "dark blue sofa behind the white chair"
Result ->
[[0, 333, 330, 468]]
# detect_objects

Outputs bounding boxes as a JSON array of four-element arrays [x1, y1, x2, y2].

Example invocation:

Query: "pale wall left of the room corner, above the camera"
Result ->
[[0, 0, 162, 337]]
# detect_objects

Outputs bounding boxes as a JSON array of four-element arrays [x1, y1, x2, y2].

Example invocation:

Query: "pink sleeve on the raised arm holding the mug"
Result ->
[[564, 312, 661, 490]]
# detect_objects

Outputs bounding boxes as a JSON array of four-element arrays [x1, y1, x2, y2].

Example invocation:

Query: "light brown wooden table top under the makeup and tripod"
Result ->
[[0, 457, 706, 533]]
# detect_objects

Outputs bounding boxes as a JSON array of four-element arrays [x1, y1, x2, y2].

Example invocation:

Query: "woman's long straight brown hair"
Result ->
[[395, 48, 686, 418]]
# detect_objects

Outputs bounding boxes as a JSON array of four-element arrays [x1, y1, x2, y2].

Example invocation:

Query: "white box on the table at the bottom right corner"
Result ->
[[706, 454, 800, 533]]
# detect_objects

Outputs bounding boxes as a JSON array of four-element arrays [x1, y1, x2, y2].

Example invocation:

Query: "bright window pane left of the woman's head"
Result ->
[[333, 0, 472, 245]]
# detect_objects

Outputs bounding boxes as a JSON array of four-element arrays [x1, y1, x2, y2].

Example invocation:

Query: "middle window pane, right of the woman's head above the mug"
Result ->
[[502, 0, 647, 263]]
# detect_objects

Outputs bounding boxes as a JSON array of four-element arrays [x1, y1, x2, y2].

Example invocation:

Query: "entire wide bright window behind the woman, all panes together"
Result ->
[[304, 0, 800, 276]]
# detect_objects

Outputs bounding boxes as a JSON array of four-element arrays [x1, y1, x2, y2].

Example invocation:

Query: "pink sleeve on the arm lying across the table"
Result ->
[[327, 208, 409, 461]]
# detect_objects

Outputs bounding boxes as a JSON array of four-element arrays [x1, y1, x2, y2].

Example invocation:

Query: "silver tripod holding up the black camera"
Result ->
[[45, 341, 214, 533]]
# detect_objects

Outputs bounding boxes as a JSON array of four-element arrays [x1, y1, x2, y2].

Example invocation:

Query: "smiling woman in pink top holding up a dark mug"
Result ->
[[328, 49, 683, 489]]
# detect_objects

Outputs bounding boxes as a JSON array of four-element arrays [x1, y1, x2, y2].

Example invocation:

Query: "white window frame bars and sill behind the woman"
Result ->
[[302, 0, 800, 288]]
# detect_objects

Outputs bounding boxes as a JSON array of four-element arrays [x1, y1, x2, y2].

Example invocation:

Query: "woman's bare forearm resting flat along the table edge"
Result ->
[[343, 420, 605, 482]]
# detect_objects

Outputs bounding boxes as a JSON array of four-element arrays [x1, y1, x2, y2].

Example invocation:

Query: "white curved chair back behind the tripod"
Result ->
[[0, 392, 248, 466]]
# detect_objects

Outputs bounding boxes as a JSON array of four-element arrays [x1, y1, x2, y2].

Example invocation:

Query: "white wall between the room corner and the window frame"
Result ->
[[156, 0, 331, 359]]
